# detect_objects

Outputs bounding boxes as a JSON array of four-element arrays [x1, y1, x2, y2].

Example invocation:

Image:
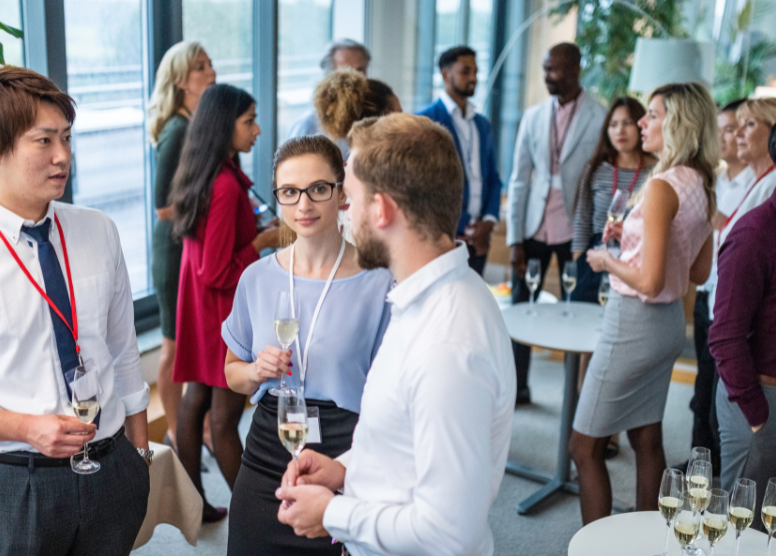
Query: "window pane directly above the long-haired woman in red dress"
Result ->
[[183, 0, 253, 175]]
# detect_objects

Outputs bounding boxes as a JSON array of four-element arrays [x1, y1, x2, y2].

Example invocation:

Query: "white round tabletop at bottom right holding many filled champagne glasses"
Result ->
[[569, 512, 774, 556]]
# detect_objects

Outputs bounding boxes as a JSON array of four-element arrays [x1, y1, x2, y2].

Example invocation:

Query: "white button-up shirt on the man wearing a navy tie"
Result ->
[[0, 202, 148, 452]]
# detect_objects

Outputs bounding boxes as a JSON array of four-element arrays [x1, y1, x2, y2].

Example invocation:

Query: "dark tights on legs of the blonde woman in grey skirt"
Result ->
[[569, 423, 666, 525]]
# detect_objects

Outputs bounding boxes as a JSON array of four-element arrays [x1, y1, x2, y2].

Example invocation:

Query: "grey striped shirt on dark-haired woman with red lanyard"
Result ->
[[571, 162, 650, 253]]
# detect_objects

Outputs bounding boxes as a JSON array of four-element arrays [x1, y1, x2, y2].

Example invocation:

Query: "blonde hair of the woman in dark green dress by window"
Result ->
[[148, 41, 204, 146]]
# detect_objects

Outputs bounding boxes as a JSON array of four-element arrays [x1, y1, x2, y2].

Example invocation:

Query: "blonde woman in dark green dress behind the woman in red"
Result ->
[[148, 41, 216, 449]]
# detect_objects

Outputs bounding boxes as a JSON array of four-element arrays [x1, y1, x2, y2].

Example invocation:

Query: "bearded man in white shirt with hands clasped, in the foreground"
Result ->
[[277, 114, 515, 556]]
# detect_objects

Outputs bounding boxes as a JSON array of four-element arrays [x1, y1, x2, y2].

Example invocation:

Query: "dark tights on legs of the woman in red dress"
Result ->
[[176, 382, 245, 506]]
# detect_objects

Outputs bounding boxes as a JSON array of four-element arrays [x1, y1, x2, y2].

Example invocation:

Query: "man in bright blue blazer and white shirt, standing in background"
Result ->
[[418, 46, 501, 276]]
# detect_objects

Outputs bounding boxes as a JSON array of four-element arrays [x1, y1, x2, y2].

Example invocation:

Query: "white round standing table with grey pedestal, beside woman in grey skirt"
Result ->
[[502, 302, 604, 514]]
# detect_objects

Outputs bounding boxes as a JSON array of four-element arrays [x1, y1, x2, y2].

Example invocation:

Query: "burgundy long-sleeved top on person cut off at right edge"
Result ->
[[709, 187, 776, 427]]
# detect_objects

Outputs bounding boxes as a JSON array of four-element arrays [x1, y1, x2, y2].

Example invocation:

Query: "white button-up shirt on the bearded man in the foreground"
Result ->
[[323, 244, 516, 556]]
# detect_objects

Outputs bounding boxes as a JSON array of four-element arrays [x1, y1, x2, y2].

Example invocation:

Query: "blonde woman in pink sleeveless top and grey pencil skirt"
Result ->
[[569, 83, 719, 524]]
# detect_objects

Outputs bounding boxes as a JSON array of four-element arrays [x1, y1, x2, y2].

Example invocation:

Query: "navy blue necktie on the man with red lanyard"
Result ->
[[22, 218, 78, 397]]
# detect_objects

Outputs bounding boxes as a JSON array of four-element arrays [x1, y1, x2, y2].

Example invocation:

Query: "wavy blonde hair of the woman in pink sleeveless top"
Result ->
[[634, 83, 719, 221]]
